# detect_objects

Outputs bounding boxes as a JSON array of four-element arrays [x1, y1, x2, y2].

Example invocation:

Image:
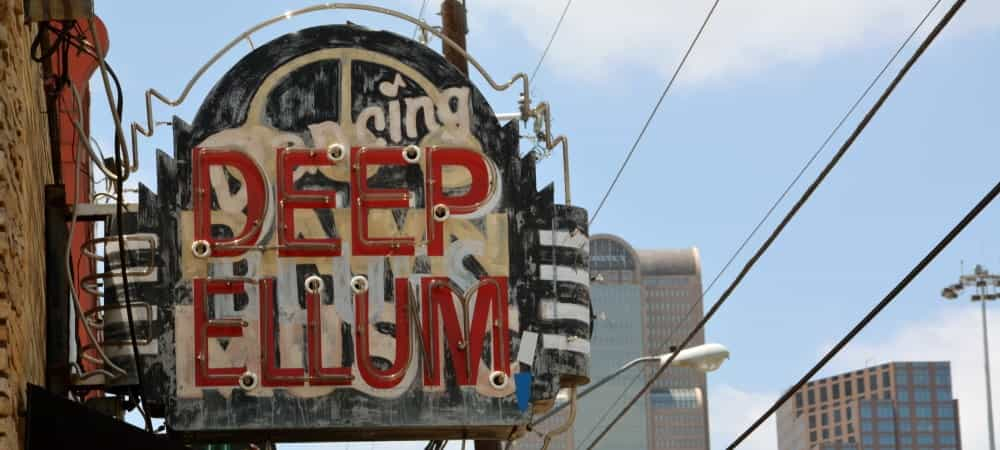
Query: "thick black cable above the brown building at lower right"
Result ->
[[727, 178, 1000, 449]]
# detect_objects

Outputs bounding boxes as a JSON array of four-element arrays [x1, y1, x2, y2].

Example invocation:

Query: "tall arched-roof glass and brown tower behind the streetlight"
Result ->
[[515, 234, 709, 450]]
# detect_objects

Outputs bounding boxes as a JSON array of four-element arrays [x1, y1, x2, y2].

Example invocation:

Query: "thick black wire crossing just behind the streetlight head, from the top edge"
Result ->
[[588, 0, 965, 450]]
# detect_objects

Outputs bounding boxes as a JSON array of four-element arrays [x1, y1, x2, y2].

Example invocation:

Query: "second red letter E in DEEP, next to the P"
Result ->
[[351, 147, 414, 256]]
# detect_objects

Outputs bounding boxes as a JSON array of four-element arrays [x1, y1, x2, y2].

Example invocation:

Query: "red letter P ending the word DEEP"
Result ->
[[424, 147, 491, 256]]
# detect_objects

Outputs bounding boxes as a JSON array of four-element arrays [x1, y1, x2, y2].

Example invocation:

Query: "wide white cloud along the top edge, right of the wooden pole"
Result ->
[[471, 0, 1000, 82]]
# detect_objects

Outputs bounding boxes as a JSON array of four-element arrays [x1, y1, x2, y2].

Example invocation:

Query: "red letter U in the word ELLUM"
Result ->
[[354, 278, 410, 389]]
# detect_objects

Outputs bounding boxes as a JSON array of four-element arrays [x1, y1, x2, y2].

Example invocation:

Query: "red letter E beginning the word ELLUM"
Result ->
[[192, 278, 246, 386]]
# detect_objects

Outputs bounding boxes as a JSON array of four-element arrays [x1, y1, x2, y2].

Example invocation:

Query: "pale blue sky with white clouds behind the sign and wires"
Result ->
[[92, 0, 1000, 450]]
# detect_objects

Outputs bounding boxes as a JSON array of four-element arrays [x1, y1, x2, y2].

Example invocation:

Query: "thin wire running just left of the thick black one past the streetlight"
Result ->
[[581, 0, 942, 442]]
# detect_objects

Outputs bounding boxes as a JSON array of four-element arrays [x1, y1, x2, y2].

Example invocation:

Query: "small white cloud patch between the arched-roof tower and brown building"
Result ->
[[708, 384, 778, 450]]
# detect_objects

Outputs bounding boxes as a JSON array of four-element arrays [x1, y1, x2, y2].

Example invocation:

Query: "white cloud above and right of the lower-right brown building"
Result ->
[[831, 305, 1000, 448]]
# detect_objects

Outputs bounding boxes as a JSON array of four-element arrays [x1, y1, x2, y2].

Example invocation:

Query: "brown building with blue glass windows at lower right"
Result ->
[[777, 362, 962, 450]]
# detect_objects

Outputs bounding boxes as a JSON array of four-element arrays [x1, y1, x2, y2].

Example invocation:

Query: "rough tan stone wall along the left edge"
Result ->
[[0, 0, 52, 450]]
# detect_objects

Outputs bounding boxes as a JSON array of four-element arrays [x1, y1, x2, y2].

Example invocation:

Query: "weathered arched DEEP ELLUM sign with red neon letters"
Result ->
[[119, 25, 591, 441]]
